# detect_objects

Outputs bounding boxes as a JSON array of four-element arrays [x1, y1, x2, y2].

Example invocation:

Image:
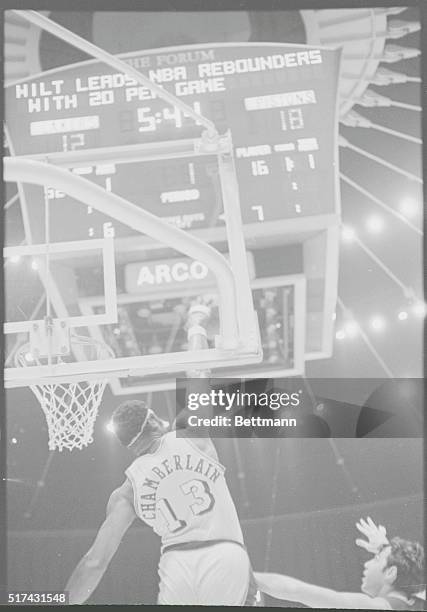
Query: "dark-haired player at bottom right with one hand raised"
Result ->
[[255, 518, 426, 610]]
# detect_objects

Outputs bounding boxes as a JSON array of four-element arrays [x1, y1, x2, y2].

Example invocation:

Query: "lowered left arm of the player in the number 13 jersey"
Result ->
[[65, 482, 136, 604]]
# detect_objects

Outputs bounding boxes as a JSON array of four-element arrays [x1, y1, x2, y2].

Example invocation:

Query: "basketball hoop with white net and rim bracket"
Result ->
[[15, 335, 114, 451]]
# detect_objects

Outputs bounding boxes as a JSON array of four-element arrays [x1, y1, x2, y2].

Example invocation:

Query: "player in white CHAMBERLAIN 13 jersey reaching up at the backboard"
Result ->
[[66, 304, 256, 606]]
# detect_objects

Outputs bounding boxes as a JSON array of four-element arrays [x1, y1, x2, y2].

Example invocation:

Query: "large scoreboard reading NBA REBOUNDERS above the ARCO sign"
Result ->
[[6, 43, 340, 242]]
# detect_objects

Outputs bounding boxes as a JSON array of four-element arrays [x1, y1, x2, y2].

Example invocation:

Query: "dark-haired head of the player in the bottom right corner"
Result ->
[[362, 538, 425, 597]]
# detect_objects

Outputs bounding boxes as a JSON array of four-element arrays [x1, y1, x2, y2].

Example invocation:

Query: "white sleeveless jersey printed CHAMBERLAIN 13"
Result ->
[[126, 431, 243, 547]]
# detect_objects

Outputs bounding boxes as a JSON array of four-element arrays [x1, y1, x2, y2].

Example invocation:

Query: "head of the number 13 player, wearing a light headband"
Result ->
[[111, 400, 169, 455]]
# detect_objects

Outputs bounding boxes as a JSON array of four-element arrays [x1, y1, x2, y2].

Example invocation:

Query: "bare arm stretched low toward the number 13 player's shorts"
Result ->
[[255, 572, 391, 610]]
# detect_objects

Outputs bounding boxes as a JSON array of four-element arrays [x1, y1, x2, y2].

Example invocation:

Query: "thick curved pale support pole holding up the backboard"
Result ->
[[4, 157, 261, 384]]
